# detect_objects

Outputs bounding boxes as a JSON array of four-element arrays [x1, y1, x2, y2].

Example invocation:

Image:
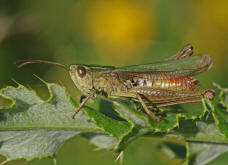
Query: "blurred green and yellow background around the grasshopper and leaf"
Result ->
[[0, 0, 228, 165]]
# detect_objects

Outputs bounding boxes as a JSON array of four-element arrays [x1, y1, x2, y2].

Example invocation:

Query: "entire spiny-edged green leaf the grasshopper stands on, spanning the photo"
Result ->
[[0, 82, 228, 165]]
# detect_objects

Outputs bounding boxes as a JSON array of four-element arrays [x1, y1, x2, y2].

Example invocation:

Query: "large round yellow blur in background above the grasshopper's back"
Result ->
[[83, 1, 156, 61]]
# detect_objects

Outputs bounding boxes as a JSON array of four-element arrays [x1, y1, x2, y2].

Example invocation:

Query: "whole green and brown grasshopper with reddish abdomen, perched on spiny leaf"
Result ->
[[16, 44, 215, 121]]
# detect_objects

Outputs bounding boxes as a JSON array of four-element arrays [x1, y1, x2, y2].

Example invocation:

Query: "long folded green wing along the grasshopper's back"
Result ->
[[115, 54, 213, 76]]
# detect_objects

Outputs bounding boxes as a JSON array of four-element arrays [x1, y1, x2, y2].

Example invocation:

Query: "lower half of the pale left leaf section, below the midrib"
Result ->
[[0, 130, 80, 160]]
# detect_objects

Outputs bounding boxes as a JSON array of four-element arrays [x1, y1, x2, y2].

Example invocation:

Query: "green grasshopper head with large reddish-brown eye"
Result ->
[[69, 65, 93, 95]]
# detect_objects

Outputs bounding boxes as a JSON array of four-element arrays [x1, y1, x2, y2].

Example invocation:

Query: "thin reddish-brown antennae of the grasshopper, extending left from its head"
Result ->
[[14, 60, 69, 71]]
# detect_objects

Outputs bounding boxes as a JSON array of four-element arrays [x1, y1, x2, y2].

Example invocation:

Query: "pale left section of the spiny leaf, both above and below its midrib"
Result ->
[[0, 83, 109, 160]]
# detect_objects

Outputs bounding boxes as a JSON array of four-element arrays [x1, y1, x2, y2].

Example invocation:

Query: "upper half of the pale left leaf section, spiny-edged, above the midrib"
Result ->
[[0, 84, 101, 132]]
